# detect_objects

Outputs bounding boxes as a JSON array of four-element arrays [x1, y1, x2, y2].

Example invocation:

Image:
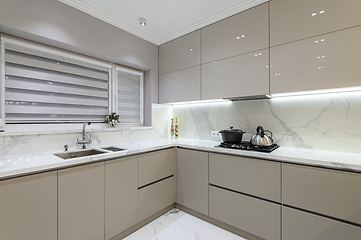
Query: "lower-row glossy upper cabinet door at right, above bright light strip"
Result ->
[[270, 26, 361, 94]]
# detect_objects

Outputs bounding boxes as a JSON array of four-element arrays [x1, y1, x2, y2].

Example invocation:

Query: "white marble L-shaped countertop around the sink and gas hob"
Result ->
[[0, 139, 361, 179]]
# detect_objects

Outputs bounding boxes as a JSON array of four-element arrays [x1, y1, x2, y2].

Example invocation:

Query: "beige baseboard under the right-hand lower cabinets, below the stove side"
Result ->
[[175, 203, 265, 240]]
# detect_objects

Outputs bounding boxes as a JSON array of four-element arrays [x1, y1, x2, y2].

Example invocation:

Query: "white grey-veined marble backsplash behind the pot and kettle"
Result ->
[[172, 92, 361, 153]]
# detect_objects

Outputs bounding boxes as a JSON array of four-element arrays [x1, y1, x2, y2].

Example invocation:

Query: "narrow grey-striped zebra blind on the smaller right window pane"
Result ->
[[117, 68, 143, 124]]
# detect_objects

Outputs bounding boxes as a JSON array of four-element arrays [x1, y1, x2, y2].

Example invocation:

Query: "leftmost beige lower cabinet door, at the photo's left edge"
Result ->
[[0, 172, 58, 240]]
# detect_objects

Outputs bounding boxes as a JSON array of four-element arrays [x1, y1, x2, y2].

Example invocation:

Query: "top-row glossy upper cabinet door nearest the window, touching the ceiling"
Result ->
[[159, 30, 201, 74]]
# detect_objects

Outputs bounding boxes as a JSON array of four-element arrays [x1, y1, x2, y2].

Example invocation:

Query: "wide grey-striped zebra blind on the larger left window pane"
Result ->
[[5, 43, 109, 123]]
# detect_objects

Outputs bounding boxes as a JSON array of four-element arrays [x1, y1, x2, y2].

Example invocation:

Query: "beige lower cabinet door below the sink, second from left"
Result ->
[[58, 162, 104, 240]]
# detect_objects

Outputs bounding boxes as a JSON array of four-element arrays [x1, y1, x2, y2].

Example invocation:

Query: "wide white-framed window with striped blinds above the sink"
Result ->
[[0, 37, 143, 129]]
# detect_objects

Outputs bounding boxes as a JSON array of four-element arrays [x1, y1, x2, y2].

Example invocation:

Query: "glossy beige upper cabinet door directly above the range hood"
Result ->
[[202, 49, 269, 100]]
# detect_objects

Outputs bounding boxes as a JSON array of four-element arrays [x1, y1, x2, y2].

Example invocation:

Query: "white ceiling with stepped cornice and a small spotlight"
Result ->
[[59, 0, 268, 45]]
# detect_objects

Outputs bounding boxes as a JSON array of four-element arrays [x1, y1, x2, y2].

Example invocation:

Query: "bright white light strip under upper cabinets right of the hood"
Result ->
[[271, 86, 361, 100]]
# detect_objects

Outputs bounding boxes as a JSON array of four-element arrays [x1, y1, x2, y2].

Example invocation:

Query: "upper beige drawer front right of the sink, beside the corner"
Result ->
[[138, 149, 175, 187]]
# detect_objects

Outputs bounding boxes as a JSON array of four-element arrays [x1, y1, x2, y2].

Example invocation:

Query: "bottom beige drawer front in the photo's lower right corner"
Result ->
[[282, 206, 361, 240]]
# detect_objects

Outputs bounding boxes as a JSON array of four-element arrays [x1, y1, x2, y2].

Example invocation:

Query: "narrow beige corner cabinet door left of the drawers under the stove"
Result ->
[[177, 148, 208, 215]]
